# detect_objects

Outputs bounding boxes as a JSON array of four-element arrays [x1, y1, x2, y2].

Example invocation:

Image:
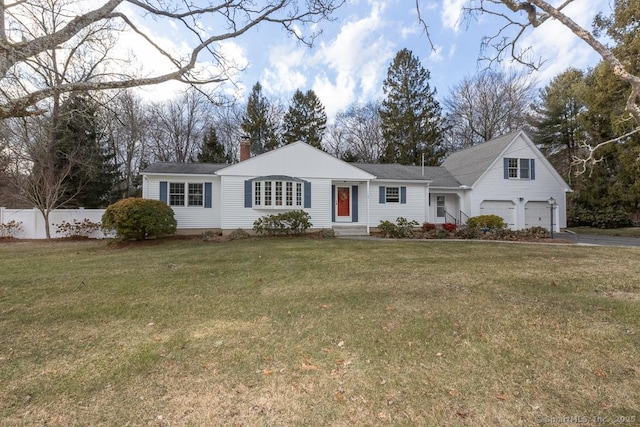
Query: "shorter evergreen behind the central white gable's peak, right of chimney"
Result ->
[[283, 89, 327, 148]]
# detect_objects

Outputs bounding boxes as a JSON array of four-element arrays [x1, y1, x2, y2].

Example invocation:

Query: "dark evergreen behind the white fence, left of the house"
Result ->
[[53, 94, 117, 208]]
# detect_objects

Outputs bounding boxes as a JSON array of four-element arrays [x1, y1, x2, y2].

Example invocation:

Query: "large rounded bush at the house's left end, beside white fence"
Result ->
[[102, 197, 177, 240]]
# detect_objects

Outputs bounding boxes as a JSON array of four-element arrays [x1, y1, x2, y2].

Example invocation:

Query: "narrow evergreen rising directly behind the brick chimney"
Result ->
[[240, 82, 279, 155]]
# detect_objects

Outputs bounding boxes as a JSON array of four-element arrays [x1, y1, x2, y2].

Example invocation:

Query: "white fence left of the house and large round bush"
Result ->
[[0, 207, 105, 239]]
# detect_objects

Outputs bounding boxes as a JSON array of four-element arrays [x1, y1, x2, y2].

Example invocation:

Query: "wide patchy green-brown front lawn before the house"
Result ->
[[0, 239, 640, 426]]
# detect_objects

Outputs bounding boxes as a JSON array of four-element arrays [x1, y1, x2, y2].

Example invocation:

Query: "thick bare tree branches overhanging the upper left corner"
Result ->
[[0, 0, 344, 119]]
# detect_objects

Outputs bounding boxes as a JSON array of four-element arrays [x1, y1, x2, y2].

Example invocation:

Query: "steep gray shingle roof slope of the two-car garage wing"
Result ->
[[442, 131, 520, 186]]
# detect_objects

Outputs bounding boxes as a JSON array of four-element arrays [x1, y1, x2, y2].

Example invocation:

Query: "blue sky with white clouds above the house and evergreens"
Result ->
[[127, 0, 610, 117]]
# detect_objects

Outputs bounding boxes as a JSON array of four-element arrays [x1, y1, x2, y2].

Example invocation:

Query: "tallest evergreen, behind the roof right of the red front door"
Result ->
[[380, 49, 445, 166]]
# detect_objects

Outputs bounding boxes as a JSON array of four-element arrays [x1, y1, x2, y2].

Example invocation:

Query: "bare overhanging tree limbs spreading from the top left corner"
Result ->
[[0, 0, 343, 118]]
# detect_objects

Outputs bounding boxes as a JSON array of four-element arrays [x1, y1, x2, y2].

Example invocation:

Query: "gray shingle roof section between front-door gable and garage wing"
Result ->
[[351, 163, 460, 187]]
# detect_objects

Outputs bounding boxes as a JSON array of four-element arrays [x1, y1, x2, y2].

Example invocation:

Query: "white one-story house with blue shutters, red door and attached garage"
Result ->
[[142, 132, 571, 234]]
